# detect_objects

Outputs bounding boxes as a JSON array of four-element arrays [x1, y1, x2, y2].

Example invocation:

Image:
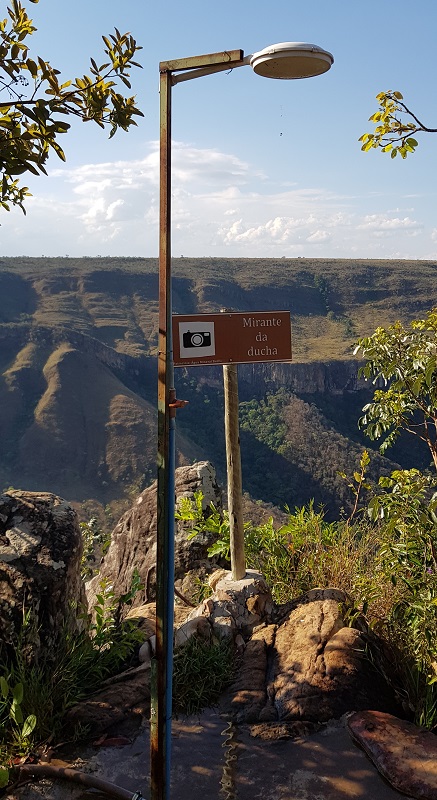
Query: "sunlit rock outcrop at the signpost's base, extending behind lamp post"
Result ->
[[63, 571, 397, 739]]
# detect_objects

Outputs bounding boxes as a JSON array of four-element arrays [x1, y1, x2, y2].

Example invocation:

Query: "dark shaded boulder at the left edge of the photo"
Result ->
[[0, 490, 86, 660]]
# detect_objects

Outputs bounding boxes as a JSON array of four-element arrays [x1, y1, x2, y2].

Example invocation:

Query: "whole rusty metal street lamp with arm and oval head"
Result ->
[[150, 42, 334, 800]]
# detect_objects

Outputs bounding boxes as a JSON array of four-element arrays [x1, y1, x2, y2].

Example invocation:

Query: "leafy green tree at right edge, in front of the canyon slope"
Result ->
[[354, 308, 437, 469]]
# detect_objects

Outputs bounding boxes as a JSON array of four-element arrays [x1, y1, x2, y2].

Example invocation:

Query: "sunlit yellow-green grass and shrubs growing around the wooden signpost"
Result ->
[[178, 493, 377, 604]]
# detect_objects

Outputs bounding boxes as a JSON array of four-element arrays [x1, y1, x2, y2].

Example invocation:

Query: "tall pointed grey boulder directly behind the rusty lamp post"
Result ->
[[86, 461, 221, 609]]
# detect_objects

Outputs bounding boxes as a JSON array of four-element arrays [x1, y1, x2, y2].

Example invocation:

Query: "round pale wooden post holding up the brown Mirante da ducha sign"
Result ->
[[223, 364, 246, 581]]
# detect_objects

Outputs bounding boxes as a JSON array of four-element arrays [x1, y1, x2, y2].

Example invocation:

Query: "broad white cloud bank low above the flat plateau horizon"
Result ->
[[0, 142, 437, 258]]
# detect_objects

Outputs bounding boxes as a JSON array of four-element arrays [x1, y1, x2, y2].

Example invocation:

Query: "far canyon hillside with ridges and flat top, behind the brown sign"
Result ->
[[0, 257, 437, 514]]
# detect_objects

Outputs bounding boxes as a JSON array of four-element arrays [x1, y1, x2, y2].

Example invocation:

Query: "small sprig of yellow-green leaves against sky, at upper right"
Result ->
[[359, 91, 437, 158]]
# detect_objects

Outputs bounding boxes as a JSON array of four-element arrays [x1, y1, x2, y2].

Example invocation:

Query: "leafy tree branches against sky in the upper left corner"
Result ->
[[0, 0, 142, 213]]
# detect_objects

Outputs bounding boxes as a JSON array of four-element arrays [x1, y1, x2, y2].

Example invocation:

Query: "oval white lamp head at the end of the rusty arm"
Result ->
[[248, 42, 334, 80]]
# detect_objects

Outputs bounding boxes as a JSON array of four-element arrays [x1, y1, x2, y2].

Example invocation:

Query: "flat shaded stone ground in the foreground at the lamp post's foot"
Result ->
[[8, 711, 418, 800]]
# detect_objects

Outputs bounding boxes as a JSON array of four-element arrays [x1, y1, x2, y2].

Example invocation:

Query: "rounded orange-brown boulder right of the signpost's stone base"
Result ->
[[230, 589, 395, 723]]
